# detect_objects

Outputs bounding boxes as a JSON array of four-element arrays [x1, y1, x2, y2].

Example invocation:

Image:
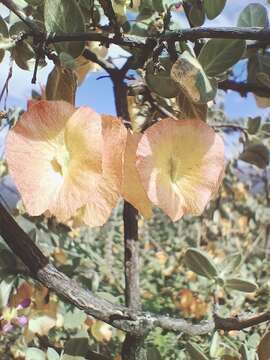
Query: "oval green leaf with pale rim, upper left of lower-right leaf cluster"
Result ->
[[185, 248, 218, 279]]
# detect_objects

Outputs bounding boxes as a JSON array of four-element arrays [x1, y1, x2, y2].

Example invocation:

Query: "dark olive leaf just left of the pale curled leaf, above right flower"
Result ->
[[145, 57, 179, 98]]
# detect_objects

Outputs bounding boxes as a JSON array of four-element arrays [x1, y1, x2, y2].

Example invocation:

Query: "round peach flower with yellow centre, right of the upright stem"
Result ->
[[136, 119, 224, 221]]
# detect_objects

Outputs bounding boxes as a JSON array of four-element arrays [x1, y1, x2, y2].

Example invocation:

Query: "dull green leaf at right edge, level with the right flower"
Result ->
[[239, 144, 270, 169]]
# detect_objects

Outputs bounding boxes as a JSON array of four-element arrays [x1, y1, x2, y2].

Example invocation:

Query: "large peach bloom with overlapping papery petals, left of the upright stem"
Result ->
[[6, 101, 126, 226]]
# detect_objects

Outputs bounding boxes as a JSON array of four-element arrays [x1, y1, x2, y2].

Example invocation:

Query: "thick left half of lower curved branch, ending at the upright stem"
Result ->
[[0, 203, 134, 323]]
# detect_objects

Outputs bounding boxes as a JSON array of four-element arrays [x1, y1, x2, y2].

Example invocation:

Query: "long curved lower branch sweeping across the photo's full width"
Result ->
[[0, 203, 270, 335]]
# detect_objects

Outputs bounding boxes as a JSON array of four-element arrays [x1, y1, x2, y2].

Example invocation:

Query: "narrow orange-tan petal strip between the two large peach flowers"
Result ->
[[122, 131, 152, 219]]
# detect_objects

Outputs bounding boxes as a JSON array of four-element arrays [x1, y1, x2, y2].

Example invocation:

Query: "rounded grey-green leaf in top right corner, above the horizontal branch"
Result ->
[[237, 3, 269, 27]]
